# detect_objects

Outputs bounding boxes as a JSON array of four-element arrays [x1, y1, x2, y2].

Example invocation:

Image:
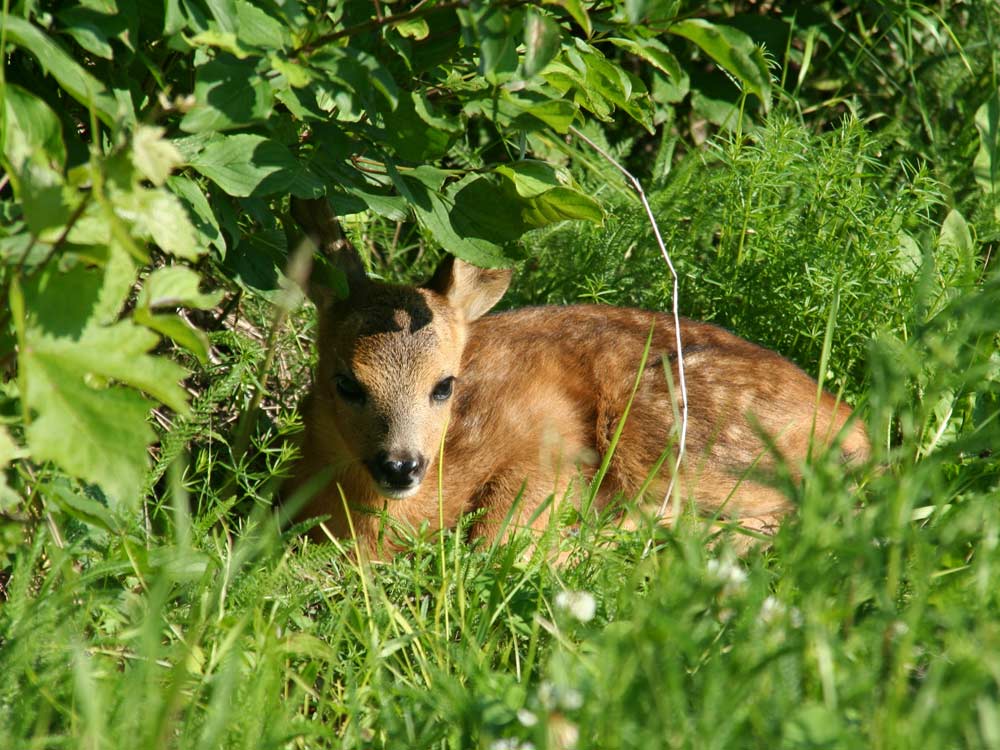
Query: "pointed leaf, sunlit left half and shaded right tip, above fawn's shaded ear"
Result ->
[[191, 133, 325, 198]]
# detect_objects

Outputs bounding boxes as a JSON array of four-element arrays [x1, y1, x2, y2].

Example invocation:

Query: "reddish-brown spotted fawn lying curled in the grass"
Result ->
[[292, 199, 869, 555]]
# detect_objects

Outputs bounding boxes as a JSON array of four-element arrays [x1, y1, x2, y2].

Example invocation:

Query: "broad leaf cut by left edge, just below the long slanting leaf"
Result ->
[[0, 83, 66, 171]]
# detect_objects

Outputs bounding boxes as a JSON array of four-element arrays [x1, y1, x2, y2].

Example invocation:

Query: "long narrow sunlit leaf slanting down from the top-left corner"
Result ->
[[0, 13, 118, 125]]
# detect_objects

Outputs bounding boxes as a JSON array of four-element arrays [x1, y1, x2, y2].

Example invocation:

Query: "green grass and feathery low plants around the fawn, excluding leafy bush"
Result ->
[[0, 3, 1000, 750]]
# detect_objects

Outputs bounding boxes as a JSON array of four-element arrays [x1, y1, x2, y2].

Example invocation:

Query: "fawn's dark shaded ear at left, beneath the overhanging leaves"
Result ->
[[291, 196, 368, 308]]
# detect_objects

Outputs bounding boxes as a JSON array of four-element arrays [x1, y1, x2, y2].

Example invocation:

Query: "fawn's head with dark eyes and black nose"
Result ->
[[297, 199, 510, 499]]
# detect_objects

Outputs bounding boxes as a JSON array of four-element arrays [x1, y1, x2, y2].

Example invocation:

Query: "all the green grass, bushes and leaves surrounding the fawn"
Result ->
[[0, 0, 1000, 748]]
